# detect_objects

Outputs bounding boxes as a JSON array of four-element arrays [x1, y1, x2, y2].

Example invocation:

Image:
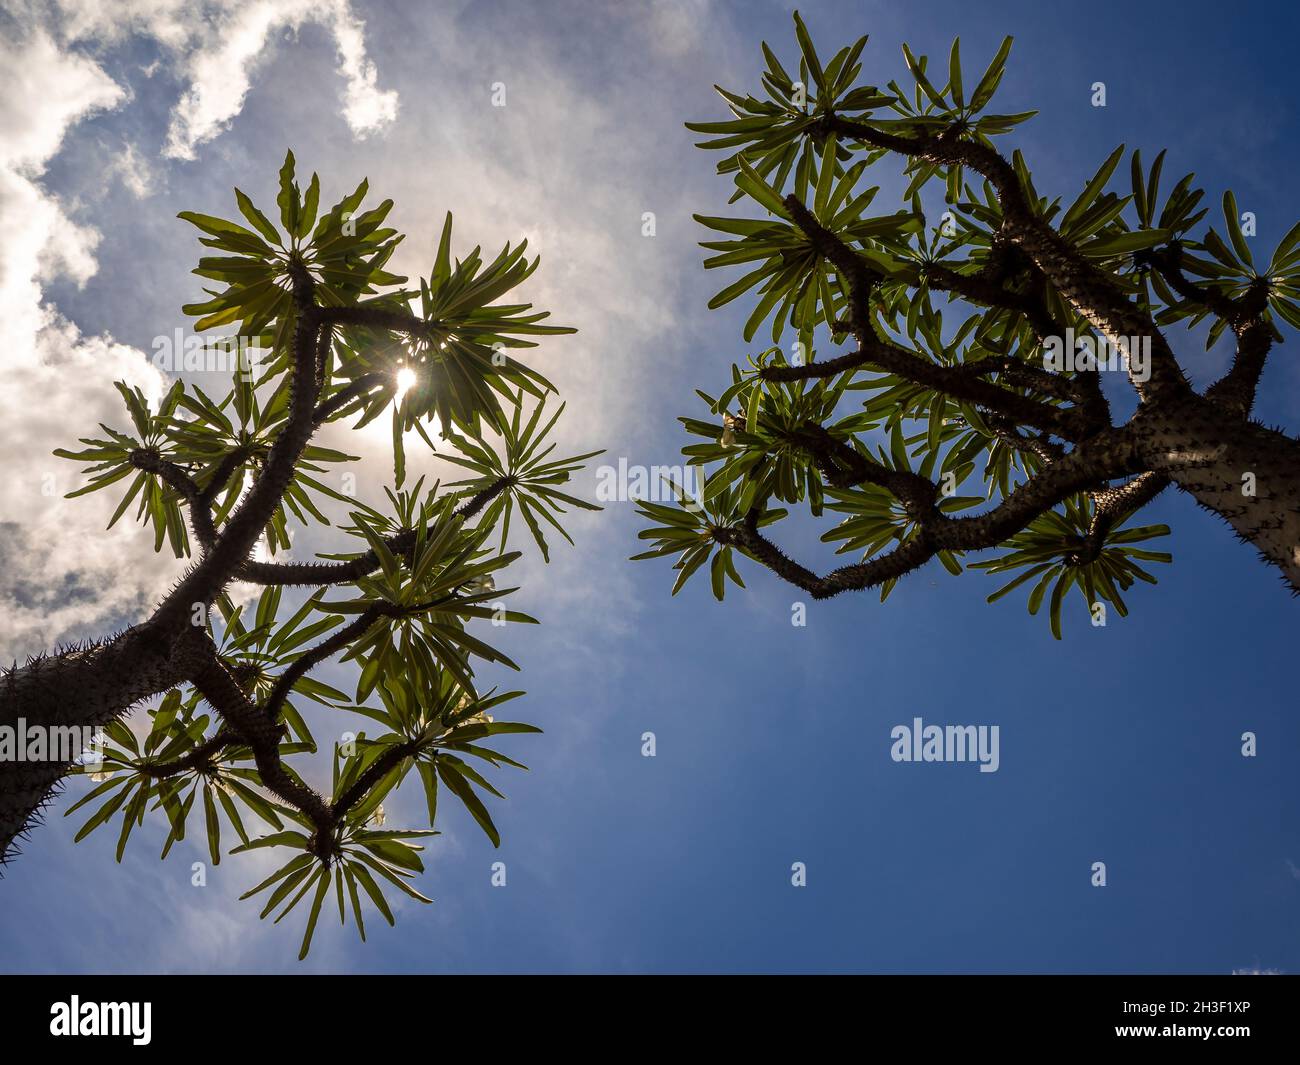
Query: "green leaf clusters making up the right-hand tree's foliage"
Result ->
[[636, 12, 1206, 632]]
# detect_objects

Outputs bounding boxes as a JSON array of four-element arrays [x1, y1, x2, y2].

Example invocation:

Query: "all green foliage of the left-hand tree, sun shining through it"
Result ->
[[57, 153, 599, 956]]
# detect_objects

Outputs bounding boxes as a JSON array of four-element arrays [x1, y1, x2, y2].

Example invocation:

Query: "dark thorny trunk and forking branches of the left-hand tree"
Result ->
[[0, 289, 512, 862]]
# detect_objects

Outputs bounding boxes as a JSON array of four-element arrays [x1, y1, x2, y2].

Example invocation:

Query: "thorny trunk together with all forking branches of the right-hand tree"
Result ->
[[710, 113, 1300, 598]]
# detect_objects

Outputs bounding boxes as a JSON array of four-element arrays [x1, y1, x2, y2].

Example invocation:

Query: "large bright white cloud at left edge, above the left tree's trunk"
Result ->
[[0, 31, 172, 657]]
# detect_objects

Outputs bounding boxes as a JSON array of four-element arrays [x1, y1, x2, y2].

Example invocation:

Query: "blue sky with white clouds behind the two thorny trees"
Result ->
[[0, 0, 1300, 973]]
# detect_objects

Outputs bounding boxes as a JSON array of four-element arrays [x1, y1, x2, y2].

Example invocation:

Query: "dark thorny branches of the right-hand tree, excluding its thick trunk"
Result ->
[[711, 113, 1294, 598]]
